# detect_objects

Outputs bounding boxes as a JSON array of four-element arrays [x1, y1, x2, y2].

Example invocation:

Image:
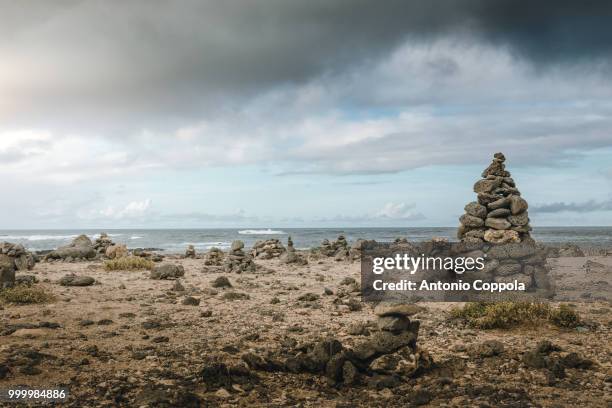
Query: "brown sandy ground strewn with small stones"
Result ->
[[0, 256, 612, 407]]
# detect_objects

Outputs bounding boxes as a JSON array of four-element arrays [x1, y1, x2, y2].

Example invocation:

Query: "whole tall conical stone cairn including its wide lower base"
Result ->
[[449, 153, 554, 297]]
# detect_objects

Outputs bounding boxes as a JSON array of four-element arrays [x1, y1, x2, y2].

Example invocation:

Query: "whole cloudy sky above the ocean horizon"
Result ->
[[0, 0, 612, 229]]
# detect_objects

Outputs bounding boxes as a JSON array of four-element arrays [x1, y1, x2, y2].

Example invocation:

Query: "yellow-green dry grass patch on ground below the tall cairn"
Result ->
[[451, 302, 580, 329]]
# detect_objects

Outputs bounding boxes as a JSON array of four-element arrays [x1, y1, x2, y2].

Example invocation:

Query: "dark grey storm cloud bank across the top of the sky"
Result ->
[[0, 0, 612, 126]]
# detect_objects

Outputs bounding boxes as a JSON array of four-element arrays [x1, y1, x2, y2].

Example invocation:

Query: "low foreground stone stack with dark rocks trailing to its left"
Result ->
[[242, 303, 432, 388]]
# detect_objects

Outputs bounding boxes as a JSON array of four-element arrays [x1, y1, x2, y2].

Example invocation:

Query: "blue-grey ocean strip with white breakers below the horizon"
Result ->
[[0, 227, 612, 253]]
